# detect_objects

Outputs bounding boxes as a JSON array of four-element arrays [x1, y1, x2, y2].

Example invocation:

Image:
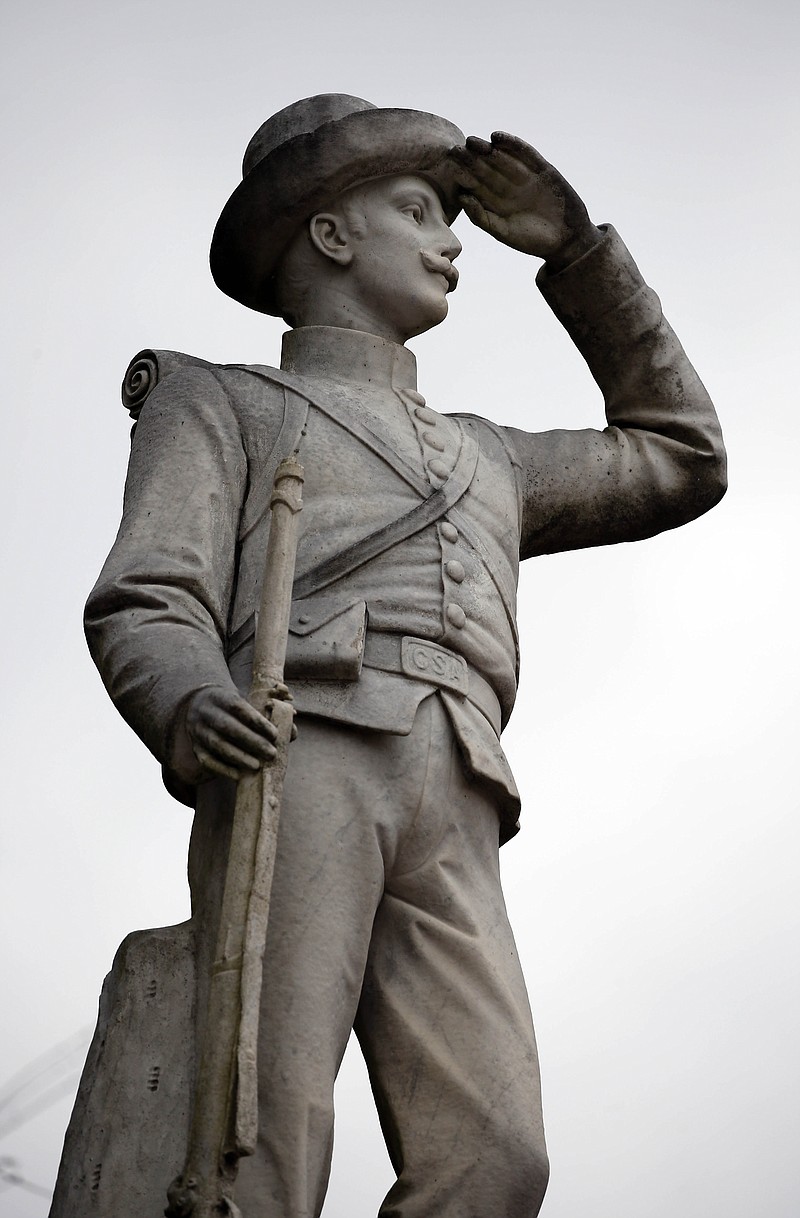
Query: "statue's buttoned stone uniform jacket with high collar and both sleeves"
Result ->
[[86, 229, 725, 833]]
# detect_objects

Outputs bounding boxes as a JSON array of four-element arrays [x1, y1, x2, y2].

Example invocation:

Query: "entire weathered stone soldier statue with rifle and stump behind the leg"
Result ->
[[52, 95, 725, 1218]]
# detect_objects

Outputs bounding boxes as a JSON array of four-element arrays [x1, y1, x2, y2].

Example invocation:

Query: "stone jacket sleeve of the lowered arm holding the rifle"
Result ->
[[85, 369, 247, 765]]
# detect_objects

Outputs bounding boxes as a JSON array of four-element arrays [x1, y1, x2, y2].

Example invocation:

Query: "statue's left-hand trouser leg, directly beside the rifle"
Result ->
[[236, 719, 387, 1218]]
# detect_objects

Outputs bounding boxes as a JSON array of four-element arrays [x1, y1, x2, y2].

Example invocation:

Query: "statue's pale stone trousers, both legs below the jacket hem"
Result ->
[[203, 695, 548, 1218]]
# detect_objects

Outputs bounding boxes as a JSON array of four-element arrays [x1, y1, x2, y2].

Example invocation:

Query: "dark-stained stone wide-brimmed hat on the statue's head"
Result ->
[[211, 93, 464, 314]]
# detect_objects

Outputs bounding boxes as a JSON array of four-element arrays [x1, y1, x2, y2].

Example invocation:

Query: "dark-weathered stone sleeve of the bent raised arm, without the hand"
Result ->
[[507, 228, 726, 558]]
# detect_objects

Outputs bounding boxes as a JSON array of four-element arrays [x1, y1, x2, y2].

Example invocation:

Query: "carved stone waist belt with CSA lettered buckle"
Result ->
[[363, 630, 502, 736]]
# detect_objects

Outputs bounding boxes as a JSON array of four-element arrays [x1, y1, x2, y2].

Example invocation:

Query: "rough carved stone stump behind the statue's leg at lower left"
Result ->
[[50, 922, 195, 1218]]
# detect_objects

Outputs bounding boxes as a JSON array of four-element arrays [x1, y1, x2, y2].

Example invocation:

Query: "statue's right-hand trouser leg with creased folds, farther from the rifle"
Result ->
[[356, 701, 548, 1218]]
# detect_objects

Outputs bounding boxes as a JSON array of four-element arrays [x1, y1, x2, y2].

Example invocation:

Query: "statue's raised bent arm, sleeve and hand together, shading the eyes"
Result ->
[[452, 132, 726, 558]]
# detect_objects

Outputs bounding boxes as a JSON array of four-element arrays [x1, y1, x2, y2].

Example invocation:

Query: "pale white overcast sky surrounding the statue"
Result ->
[[0, 0, 800, 1218]]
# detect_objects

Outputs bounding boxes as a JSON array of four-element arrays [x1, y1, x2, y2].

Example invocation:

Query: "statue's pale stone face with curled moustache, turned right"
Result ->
[[347, 174, 461, 342]]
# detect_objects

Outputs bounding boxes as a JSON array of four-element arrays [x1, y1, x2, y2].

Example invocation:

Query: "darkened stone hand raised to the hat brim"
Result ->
[[451, 132, 603, 270]]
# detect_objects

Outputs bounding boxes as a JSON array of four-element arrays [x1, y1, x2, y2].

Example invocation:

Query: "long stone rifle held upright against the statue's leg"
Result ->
[[164, 457, 303, 1218]]
